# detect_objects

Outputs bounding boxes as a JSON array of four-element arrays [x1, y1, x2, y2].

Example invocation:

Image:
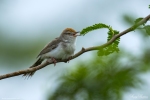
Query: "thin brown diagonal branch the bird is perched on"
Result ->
[[0, 15, 150, 80]]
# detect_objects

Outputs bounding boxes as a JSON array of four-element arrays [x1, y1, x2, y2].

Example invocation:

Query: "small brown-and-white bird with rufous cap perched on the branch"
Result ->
[[23, 28, 80, 77]]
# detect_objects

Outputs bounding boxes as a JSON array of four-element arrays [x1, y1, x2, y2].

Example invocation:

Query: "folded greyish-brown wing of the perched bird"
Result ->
[[37, 38, 60, 57]]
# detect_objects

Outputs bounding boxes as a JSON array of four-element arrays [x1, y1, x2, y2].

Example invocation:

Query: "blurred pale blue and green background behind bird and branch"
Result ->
[[0, 0, 150, 100]]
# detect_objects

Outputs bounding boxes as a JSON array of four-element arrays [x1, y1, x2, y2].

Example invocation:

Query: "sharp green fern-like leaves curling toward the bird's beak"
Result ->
[[80, 23, 120, 56]]
